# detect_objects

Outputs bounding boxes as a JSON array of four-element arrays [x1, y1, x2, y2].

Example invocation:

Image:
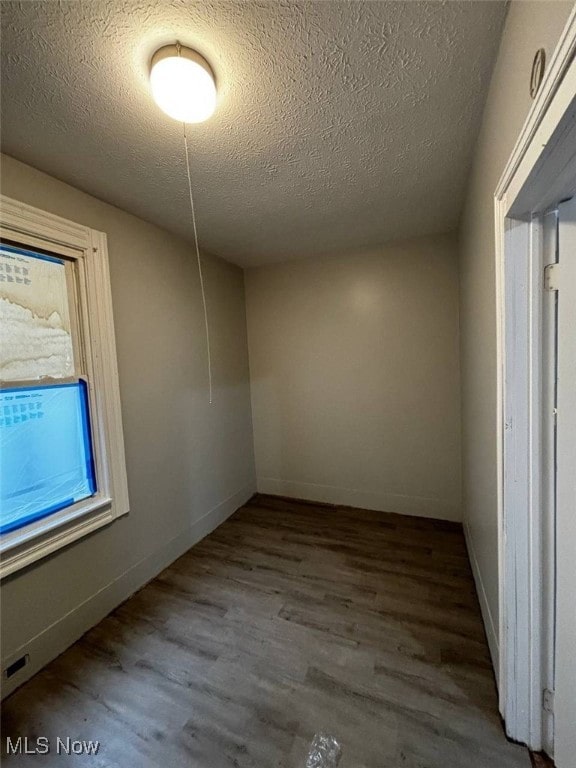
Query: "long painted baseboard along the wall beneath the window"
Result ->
[[2, 483, 255, 698]]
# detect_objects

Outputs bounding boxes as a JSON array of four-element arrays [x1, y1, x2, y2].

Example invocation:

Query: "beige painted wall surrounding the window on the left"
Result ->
[[1, 156, 255, 682]]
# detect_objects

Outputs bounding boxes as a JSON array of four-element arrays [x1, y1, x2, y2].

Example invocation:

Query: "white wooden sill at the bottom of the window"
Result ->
[[0, 497, 117, 579]]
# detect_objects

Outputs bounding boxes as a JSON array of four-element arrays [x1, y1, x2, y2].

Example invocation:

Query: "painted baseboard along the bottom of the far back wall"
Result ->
[[257, 477, 462, 522]]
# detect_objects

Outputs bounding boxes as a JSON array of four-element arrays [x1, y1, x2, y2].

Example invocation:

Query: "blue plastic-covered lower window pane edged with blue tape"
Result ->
[[0, 381, 96, 533]]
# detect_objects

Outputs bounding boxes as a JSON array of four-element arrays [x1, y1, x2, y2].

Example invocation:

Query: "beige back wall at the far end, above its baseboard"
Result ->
[[246, 236, 460, 520]]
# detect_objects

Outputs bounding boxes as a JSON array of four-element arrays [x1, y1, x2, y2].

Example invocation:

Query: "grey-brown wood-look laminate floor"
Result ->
[[2, 496, 530, 768]]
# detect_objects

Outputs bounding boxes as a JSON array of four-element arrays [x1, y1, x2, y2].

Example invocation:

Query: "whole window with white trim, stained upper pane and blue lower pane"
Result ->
[[0, 196, 128, 576]]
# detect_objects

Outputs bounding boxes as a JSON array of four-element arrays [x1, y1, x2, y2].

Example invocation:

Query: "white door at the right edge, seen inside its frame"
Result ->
[[554, 198, 576, 768]]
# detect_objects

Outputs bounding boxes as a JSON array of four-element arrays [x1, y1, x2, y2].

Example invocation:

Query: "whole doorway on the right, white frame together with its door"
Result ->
[[495, 13, 576, 768]]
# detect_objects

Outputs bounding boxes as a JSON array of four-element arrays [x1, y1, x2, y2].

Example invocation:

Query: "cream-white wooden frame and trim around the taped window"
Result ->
[[0, 195, 129, 578]]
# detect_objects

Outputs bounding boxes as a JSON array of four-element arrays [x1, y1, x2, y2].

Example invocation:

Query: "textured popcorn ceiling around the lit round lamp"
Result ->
[[1, 0, 505, 265]]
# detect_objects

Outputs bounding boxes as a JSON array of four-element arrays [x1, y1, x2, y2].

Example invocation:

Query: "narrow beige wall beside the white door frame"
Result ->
[[460, 0, 573, 670]]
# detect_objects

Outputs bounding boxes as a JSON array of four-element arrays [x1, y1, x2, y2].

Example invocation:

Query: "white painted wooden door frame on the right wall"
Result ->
[[494, 6, 576, 750]]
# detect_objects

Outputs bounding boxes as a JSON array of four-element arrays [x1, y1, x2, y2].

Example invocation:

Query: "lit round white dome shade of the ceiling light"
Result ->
[[150, 44, 216, 123]]
